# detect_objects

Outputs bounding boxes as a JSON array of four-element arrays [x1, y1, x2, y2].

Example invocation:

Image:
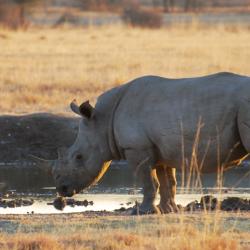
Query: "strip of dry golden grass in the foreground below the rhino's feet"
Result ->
[[0, 213, 250, 250]]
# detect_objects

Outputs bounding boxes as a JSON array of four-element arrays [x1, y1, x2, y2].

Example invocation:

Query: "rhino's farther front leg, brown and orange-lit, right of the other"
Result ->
[[156, 165, 178, 213]]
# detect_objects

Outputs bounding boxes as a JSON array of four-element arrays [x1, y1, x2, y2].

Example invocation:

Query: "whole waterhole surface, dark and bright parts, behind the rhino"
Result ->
[[0, 162, 250, 214]]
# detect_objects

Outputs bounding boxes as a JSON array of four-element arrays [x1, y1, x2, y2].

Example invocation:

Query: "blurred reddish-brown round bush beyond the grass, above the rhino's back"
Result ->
[[122, 7, 163, 28]]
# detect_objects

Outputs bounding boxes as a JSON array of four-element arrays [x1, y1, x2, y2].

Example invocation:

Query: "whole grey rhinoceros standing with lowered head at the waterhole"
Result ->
[[34, 72, 250, 214]]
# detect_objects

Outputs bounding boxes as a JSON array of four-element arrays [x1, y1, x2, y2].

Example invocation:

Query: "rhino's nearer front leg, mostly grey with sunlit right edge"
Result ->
[[126, 151, 160, 214]]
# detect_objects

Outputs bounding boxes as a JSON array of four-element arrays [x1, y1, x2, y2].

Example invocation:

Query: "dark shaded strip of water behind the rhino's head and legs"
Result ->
[[0, 165, 250, 192]]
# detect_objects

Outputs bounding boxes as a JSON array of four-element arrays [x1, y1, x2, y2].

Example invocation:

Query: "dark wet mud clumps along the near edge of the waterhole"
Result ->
[[0, 195, 250, 215]]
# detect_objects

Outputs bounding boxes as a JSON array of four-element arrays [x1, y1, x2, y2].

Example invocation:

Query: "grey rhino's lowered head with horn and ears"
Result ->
[[33, 101, 111, 197]]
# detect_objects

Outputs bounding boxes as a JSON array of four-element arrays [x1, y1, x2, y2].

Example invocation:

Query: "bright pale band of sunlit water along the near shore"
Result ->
[[0, 189, 250, 214]]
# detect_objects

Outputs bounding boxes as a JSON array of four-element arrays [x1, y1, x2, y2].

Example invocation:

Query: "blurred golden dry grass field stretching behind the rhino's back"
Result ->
[[0, 23, 250, 113]]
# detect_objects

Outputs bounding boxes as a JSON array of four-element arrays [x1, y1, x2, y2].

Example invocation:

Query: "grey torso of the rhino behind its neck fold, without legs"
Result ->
[[114, 73, 250, 172]]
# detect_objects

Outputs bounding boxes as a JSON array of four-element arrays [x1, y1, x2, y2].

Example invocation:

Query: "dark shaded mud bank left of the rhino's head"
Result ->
[[0, 113, 79, 164]]
